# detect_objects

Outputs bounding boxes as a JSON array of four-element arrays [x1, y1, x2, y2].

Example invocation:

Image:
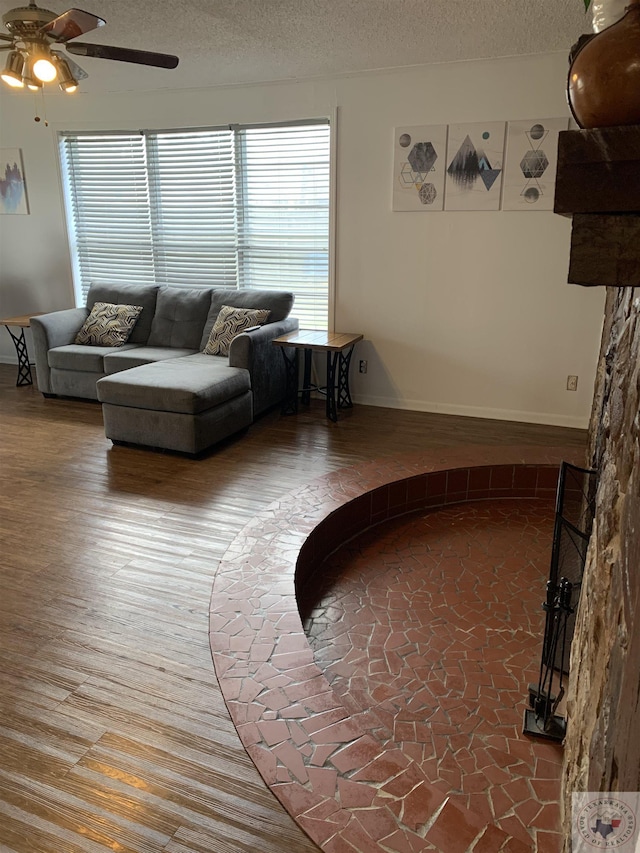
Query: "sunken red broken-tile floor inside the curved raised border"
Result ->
[[303, 499, 561, 850]]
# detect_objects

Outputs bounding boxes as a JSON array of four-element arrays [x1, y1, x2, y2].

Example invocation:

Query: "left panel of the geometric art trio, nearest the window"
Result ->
[[393, 124, 447, 210]]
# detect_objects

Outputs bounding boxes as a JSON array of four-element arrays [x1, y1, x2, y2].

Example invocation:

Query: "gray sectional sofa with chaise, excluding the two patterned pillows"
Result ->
[[31, 284, 298, 454]]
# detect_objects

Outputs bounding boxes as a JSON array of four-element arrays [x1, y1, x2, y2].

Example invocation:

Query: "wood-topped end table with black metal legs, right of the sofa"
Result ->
[[273, 330, 363, 423]]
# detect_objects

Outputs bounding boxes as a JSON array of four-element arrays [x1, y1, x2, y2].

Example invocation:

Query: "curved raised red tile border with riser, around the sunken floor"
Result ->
[[210, 447, 583, 853]]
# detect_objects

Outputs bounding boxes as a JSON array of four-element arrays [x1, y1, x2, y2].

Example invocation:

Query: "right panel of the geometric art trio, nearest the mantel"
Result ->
[[502, 118, 569, 210]]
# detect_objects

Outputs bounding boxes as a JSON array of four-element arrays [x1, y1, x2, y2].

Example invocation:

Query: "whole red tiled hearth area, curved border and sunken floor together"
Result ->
[[211, 447, 582, 853]]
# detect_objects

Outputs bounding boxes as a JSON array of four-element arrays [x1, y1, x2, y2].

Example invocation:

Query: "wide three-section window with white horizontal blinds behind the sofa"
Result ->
[[60, 121, 330, 329]]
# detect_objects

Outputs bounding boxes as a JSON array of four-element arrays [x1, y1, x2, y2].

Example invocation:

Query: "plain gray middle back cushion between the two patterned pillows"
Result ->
[[147, 287, 211, 350]]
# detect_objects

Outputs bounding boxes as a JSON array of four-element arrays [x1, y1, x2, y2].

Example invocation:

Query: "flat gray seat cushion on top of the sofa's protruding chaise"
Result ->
[[96, 353, 251, 414]]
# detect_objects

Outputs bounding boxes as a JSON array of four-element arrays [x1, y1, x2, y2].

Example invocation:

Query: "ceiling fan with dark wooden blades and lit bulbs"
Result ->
[[0, 0, 178, 92]]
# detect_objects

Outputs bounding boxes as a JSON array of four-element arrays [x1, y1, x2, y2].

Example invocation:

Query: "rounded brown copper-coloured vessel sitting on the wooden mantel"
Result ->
[[567, 0, 640, 128]]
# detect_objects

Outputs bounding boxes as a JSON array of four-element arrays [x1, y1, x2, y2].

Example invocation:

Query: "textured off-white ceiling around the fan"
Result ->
[[0, 0, 588, 92]]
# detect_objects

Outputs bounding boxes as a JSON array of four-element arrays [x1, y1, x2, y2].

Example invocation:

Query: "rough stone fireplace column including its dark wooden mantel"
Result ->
[[555, 127, 640, 853]]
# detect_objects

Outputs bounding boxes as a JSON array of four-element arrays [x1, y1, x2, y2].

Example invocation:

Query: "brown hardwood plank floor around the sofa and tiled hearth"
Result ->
[[0, 365, 586, 853]]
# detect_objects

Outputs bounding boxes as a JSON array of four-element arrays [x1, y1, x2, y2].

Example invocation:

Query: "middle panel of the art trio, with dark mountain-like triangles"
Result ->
[[444, 121, 506, 210]]
